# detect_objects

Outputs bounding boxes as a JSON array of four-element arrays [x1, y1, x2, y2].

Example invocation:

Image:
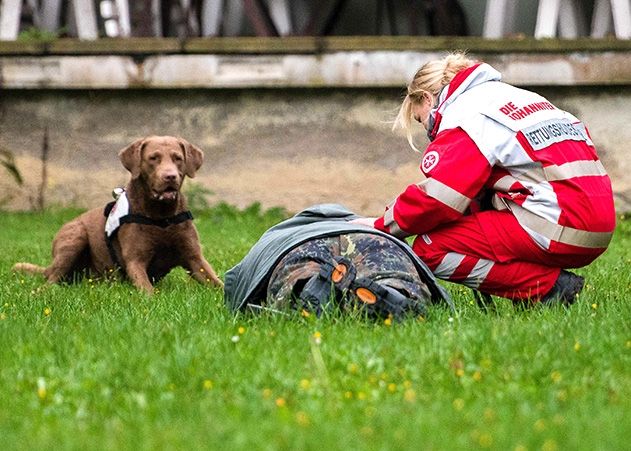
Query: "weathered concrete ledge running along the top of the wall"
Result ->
[[0, 37, 631, 89]]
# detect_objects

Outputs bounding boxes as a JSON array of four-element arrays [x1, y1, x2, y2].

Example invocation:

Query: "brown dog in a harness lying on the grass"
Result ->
[[13, 136, 223, 293]]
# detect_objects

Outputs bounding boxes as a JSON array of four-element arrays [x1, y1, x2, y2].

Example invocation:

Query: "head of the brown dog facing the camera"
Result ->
[[118, 136, 204, 202]]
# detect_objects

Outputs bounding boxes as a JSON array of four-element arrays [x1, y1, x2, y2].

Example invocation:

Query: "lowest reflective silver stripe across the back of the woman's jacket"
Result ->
[[509, 202, 613, 249]]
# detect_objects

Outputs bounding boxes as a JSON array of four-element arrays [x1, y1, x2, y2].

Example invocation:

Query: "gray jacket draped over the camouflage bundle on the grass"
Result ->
[[224, 204, 453, 311]]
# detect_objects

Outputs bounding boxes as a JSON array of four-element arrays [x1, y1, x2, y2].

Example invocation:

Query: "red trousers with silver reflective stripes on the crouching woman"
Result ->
[[413, 211, 604, 301]]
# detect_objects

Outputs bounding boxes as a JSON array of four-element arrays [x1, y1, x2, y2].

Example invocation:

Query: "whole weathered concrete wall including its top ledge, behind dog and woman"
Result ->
[[0, 37, 631, 215]]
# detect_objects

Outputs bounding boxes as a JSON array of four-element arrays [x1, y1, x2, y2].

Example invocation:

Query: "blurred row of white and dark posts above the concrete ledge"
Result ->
[[0, 0, 631, 40]]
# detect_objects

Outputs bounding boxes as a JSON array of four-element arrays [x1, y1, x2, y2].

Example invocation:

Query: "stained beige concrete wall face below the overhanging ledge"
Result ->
[[0, 85, 631, 214]]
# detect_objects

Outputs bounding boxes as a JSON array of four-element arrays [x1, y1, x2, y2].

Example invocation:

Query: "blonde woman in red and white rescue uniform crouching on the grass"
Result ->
[[361, 53, 615, 304]]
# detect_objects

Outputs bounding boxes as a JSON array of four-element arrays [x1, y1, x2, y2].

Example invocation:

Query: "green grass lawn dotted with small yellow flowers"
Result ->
[[0, 206, 631, 450]]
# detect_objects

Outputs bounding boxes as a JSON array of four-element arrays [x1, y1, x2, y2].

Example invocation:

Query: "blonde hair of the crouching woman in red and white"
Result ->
[[392, 52, 477, 152]]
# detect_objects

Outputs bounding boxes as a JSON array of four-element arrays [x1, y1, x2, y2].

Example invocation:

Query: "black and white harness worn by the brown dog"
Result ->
[[103, 189, 193, 268]]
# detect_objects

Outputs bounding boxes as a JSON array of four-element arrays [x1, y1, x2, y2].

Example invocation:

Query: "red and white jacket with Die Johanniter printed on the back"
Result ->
[[375, 63, 615, 253]]
